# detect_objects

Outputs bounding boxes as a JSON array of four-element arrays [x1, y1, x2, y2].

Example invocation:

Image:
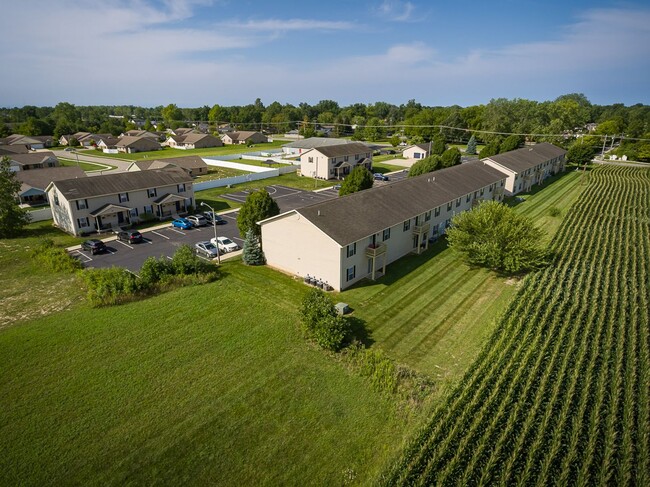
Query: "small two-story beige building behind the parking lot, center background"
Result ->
[[300, 142, 372, 179]]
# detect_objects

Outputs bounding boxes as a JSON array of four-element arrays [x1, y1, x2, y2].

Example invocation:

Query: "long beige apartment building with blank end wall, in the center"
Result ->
[[259, 161, 506, 290]]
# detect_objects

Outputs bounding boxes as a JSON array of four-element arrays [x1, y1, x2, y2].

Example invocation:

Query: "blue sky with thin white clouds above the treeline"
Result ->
[[0, 0, 650, 107]]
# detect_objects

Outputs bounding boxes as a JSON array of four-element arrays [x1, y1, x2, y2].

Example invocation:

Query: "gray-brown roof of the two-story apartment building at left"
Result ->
[[52, 169, 192, 200]]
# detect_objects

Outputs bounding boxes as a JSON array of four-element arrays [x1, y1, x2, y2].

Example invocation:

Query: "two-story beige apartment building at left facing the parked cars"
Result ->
[[45, 169, 194, 235]]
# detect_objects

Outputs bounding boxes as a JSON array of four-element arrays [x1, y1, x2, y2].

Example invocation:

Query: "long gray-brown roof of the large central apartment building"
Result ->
[[288, 161, 506, 246]]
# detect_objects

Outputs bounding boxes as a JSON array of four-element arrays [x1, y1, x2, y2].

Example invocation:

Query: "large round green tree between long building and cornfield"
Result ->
[[447, 201, 548, 274]]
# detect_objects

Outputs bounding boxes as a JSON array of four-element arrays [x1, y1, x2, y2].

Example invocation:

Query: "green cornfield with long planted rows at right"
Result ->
[[385, 167, 650, 485]]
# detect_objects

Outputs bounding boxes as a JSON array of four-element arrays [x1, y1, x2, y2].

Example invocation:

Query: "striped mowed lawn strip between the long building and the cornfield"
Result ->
[[340, 172, 584, 389]]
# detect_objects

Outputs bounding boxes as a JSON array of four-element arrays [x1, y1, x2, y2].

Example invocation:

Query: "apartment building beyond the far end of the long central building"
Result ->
[[482, 142, 566, 195]]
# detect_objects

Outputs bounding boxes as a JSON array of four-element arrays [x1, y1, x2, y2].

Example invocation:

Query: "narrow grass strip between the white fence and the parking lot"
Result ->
[[194, 172, 337, 211]]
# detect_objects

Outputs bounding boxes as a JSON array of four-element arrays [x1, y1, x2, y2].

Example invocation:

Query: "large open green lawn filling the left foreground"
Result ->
[[0, 260, 418, 486]]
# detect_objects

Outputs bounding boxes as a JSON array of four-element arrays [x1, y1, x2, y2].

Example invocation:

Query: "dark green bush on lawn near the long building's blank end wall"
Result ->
[[300, 288, 350, 352]]
